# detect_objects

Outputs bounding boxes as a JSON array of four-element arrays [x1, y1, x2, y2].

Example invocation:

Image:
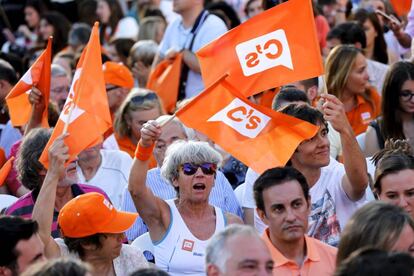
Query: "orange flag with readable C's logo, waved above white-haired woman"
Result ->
[[176, 78, 318, 173]]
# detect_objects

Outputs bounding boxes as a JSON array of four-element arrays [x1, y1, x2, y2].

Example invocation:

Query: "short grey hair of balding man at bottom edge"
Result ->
[[206, 224, 260, 273]]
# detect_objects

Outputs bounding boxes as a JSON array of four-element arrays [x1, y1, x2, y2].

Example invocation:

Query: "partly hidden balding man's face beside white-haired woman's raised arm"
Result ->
[[154, 122, 187, 167]]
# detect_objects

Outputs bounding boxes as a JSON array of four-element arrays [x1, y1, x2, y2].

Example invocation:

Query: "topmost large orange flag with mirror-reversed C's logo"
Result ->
[[196, 0, 323, 97]]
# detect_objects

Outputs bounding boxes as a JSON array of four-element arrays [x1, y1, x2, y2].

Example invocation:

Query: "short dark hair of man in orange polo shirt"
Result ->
[[253, 167, 309, 212]]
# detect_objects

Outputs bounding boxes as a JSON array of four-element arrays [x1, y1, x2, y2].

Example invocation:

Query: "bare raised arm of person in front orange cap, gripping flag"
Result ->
[[32, 134, 69, 258]]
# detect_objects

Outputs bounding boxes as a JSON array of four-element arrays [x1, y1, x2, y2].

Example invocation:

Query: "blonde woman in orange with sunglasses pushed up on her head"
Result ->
[[114, 89, 163, 168]]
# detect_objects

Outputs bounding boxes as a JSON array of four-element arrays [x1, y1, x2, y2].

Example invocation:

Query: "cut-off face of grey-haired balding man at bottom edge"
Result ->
[[219, 235, 273, 276]]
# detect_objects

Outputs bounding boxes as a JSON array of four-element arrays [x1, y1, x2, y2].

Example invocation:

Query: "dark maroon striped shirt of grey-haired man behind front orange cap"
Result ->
[[5, 184, 109, 238]]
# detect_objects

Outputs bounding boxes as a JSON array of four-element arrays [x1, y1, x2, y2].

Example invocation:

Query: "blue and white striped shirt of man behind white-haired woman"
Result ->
[[122, 168, 242, 241]]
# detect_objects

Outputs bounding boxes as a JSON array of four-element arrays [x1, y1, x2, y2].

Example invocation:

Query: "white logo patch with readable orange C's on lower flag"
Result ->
[[207, 99, 271, 138]]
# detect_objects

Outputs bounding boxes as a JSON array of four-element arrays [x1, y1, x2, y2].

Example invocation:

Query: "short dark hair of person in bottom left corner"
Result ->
[[0, 216, 39, 270]]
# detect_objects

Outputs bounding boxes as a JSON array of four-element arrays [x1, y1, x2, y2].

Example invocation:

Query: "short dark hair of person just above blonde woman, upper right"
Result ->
[[326, 22, 367, 49]]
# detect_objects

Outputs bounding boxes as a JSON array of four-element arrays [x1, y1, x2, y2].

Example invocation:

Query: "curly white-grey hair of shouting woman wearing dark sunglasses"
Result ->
[[161, 140, 223, 183]]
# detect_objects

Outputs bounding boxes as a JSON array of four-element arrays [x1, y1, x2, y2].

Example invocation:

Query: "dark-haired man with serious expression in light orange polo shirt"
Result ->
[[254, 167, 337, 276]]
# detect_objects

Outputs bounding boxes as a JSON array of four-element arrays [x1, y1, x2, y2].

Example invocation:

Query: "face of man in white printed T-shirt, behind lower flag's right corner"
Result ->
[[291, 123, 330, 171]]
